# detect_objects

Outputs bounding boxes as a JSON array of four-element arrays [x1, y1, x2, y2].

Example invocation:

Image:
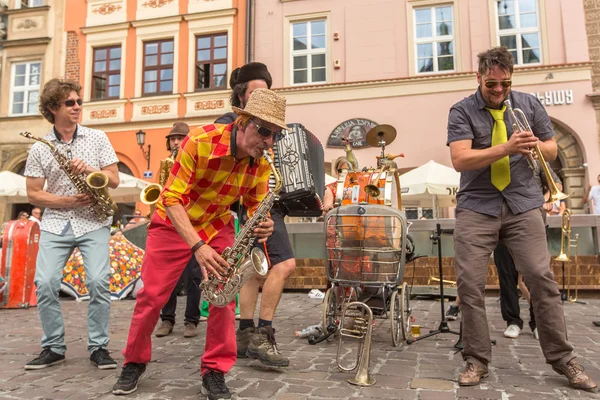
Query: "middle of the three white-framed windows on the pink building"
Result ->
[[415, 6, 454, 73]]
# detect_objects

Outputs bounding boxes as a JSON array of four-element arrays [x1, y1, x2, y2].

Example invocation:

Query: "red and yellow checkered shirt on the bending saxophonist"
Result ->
[[156, 124, 271, 242]]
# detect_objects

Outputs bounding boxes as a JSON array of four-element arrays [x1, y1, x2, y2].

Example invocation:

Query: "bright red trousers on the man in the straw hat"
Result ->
[[123, 213, 237, 375]]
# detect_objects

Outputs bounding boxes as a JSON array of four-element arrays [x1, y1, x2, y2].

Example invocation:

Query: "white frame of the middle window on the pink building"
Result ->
[[413, 3, 457, 75]]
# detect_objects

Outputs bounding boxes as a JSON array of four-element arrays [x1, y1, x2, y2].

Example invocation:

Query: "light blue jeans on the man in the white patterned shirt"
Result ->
[[35, 225, 110, 354]]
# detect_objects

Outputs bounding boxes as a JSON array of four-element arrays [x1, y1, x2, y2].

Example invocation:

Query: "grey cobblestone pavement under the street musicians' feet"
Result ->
[[0, 293, 600, 400]]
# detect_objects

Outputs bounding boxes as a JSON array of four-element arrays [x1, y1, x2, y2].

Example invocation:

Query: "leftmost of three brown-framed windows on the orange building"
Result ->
[[92, 46, 121, 99]]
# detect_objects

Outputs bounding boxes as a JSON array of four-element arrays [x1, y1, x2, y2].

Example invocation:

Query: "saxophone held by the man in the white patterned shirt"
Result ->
[[20, 132, 117, 222]]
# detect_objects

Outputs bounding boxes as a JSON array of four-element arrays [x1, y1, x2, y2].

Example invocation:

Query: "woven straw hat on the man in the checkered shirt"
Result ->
[[231, 89, 288, 130]]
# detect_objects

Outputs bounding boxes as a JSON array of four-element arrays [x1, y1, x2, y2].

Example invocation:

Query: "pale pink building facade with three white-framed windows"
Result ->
[[251, 0, 600, 212]]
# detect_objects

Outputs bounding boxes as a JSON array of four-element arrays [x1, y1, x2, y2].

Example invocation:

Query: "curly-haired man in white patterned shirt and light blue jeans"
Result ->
[[25, 79, 119, 369]]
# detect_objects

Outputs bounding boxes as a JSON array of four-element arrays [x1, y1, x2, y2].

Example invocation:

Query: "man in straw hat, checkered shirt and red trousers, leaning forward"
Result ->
[[113, 89, 286, 400]]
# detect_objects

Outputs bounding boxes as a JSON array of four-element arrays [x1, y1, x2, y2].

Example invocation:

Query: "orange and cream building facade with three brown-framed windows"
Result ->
[[59, 0, 248, 216]]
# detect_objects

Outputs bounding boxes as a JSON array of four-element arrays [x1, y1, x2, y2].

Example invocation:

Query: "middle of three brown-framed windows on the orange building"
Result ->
[[142, 39, 173, 95]]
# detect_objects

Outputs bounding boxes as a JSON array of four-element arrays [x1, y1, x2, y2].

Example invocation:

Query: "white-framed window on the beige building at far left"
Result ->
[[10, 61, 42, 115]]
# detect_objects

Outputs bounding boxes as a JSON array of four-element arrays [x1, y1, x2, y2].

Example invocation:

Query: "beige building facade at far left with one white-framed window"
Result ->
[[0, 0, 64, 221]]
